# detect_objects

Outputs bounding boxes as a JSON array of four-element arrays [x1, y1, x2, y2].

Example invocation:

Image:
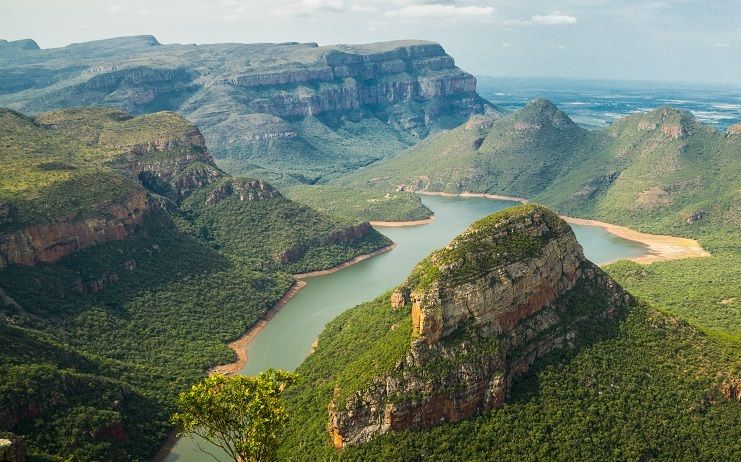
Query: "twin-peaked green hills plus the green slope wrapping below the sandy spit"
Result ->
[[340, 99, 741, 342]]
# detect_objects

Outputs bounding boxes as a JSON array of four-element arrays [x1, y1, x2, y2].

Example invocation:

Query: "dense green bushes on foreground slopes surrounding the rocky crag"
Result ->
[[281, 303, 741, 461]]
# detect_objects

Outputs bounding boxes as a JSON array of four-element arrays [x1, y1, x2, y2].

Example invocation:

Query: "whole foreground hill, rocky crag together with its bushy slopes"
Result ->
[[282, 205, 741, 461]]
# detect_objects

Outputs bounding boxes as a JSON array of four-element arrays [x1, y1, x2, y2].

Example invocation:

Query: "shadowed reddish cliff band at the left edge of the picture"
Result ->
[[0, 190, 160, 268]]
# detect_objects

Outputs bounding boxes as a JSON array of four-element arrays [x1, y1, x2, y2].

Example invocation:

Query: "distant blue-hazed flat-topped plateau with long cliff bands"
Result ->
[[0, 36, 497, 184]]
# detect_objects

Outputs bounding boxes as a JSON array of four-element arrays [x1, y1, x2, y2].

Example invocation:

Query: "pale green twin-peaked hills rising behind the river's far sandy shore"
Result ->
[[340, 99, 741, 238]]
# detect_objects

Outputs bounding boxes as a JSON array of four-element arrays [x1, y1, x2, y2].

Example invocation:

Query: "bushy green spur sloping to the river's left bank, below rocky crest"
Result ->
[[181, 179, 391, 273]]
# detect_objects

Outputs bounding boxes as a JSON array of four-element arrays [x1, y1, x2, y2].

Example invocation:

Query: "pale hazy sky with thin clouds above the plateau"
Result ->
[[5, 0, 741, 84]]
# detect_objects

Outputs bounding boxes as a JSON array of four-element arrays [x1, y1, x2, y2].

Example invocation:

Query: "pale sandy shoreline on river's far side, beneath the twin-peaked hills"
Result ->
[[417, 191, 710, 264]]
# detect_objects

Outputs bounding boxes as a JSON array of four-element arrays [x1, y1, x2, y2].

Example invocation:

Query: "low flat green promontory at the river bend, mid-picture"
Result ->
[[286, 185, 432, 221]]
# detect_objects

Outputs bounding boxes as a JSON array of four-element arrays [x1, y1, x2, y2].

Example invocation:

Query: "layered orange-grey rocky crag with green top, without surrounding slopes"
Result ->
[[328, 205, 630, 447]]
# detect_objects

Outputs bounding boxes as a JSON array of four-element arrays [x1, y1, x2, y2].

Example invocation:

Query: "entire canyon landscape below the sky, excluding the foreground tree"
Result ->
[[0, 32, 741, 462]]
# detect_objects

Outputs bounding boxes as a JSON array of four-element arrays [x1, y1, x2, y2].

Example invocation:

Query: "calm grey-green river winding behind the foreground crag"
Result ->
[[165, 196, 648, 462]]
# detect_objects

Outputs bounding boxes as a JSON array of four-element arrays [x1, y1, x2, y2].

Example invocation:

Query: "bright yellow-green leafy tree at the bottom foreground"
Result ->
[[172, 369, 297, 462]]
